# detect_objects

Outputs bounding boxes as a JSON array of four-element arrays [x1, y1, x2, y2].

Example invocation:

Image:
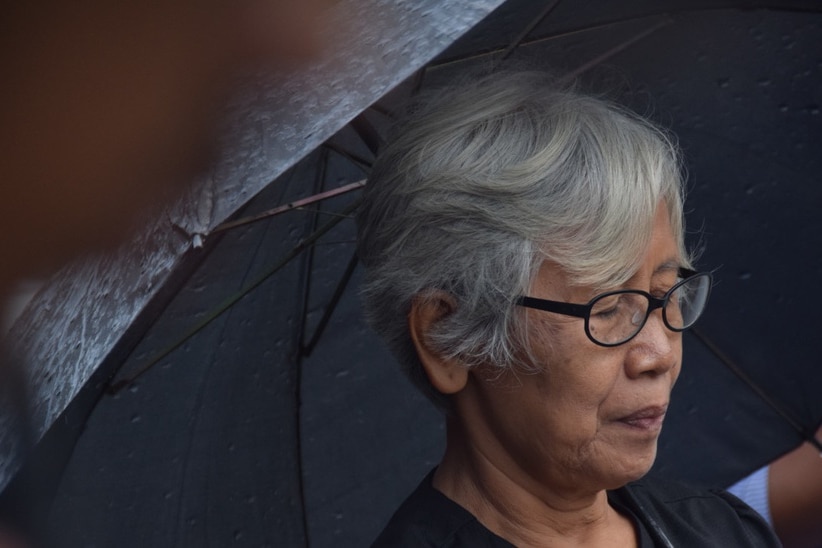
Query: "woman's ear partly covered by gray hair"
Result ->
[[408, 291, 468, 394]]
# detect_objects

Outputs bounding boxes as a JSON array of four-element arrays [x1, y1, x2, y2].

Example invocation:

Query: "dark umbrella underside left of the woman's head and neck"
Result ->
[[41, 125, 440, 546]]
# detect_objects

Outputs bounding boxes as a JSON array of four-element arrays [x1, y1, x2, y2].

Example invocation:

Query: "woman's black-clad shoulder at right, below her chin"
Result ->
[[614, 478, 781, 547]]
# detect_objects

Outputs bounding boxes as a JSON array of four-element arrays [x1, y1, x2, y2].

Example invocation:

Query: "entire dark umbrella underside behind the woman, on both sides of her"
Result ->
[[4, 0, 822, 546]]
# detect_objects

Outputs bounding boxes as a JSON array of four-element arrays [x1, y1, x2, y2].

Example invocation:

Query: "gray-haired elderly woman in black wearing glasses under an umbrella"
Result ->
[[358, 72, 778, 547]]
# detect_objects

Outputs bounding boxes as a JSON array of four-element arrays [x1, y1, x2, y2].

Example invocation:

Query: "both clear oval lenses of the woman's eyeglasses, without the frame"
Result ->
[[588, 275, 710, 345]]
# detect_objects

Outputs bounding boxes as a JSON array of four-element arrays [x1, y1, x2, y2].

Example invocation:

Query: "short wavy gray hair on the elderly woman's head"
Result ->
[[357, 72, 689, 406]]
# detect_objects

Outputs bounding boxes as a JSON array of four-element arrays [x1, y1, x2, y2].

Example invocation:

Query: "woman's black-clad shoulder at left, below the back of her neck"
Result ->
[[372, 471, 511, 548]]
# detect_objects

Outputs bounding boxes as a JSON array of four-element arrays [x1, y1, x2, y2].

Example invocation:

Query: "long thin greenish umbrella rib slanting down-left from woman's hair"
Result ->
[[108, 201, 359, 394]]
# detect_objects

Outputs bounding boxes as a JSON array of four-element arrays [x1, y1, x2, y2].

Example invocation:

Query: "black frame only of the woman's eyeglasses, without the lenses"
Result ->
[[514, 268, 713, 347]]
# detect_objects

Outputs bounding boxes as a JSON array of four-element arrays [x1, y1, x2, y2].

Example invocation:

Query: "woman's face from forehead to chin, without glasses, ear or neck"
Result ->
[[466, 207, 682, 493]]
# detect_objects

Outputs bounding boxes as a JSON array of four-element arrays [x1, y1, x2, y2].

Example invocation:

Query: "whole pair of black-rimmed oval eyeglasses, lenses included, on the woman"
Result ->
[[515, 268, 711, 346]]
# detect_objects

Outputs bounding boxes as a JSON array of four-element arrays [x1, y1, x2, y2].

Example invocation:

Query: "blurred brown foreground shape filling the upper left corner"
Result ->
[[0, 0, 329, 294]]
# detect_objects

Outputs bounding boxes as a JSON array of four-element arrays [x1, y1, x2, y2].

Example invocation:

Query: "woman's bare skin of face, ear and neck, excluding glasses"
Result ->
[[416, 204, 682, 546]]
